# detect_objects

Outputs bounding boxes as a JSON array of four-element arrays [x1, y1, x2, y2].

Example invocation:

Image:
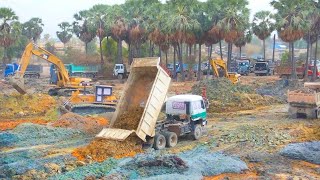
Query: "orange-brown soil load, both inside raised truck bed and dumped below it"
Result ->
[[72, 107, 143, 162]]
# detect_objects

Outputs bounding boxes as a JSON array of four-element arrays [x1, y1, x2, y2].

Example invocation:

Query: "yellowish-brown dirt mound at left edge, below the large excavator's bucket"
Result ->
[[0, 94, 57, 119]]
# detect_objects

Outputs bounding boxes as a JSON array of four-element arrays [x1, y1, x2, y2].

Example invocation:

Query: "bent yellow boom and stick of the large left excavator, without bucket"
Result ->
[[17, 43, 69, 87]]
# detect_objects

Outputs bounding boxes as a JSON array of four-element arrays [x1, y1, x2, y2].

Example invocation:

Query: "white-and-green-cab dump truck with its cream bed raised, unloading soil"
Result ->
[[96, 58, 206, 149]]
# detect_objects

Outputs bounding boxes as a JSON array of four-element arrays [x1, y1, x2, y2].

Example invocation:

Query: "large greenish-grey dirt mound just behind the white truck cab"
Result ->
[[192, 78, 277, 112]]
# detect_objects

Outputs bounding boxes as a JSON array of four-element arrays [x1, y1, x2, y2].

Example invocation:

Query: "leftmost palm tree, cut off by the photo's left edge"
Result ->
[[0, 8, 21, 64]]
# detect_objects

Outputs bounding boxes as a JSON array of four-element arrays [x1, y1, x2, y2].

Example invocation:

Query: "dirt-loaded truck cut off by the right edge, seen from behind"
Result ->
[[288, 82, 320, 119]]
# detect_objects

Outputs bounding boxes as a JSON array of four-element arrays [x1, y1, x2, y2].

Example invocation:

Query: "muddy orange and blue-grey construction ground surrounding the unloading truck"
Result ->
[[0, 75, 320, 179]]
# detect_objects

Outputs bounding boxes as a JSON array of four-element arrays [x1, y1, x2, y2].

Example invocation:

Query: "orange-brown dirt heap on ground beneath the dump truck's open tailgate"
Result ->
[[72, 136, 142, 162]]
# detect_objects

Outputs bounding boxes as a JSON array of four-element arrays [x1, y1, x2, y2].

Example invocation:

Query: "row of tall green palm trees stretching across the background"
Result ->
[[0, 0, 320, 80]]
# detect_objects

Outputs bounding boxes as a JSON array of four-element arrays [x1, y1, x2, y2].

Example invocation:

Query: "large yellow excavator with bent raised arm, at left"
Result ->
[[10, 42, 91, 95]]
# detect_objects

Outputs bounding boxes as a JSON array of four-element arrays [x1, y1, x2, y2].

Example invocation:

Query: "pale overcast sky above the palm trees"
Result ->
[[0, 0, 272, 37]]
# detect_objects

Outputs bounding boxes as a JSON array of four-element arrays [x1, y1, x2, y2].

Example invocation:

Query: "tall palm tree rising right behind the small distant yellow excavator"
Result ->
[[217, 0, 249, 70]]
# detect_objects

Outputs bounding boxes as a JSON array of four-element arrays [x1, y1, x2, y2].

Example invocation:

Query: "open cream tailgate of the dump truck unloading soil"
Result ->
[[96, 128, 134, 141]]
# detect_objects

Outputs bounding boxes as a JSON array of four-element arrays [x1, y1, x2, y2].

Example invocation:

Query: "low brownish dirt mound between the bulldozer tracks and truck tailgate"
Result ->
[[52, 113, 109, 134]]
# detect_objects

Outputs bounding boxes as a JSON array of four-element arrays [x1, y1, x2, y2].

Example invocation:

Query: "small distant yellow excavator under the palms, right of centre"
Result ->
[[210, 59, 241, 84]]
